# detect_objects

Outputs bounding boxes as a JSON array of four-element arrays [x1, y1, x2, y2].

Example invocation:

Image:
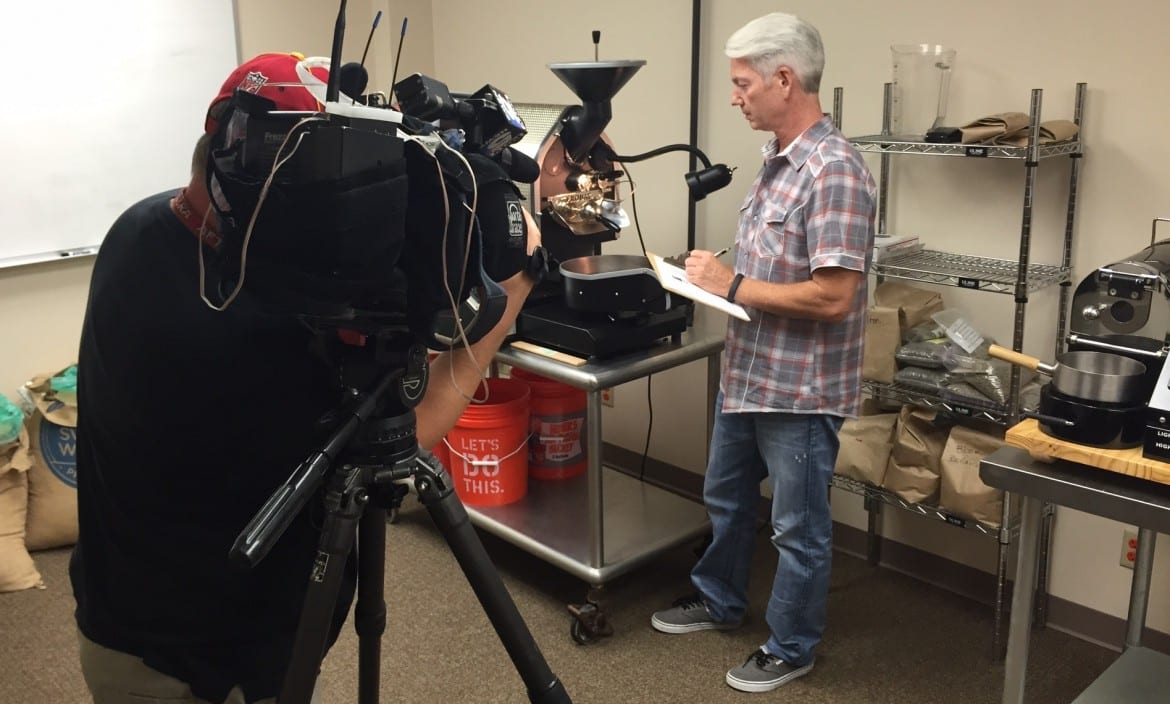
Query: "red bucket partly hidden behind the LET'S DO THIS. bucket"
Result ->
[[511, 367, 589, 479]]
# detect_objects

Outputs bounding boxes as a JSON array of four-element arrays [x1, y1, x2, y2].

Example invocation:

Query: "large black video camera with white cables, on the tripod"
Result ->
[[207, 58, 538, 348]]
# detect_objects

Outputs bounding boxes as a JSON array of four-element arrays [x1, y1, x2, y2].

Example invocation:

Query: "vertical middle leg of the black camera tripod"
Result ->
[[353, 505, 386, 704]]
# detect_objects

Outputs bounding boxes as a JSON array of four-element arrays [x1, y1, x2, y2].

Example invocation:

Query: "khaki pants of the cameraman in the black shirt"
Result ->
[[77, 631, 322, 704]]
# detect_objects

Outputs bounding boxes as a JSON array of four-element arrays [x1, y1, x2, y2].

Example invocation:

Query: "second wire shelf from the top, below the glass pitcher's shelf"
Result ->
[[873, 249, 1071, 294]]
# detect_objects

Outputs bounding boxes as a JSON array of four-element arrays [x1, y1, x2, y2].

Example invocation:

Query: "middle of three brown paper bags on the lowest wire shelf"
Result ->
[[882, 406, 948, 503]]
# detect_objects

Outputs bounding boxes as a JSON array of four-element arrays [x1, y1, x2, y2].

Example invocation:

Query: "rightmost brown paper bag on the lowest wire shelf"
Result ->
[[938, 426, 1005, 527]]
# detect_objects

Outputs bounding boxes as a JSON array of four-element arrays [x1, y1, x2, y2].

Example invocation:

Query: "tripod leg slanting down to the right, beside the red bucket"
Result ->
[[414, 462, 572, 704]]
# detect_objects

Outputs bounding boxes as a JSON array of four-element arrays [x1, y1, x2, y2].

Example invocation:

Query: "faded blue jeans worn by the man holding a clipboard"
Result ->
[[690, 393, 842, 667]]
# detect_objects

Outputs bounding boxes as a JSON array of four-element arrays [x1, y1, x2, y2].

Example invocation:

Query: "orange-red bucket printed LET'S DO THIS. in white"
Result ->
[[445, 378, 531, 506]]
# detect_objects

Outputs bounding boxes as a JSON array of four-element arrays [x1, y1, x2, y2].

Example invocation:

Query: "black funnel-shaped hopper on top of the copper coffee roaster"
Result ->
[[549, 58, 646, 163]]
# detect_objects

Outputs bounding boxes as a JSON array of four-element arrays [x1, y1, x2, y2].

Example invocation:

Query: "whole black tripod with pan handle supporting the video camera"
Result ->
[[232, 363, 571, 704]]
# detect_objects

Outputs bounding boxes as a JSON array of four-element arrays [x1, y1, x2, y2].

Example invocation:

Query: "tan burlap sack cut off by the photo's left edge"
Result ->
[[0, 428, 44, 592]]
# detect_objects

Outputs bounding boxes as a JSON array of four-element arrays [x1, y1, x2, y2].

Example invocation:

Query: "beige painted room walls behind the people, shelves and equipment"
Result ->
[[0, 0, 1170, 631]]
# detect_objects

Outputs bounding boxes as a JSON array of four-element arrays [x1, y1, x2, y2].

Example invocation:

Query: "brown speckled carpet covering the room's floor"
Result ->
[[0, 498, 1116, 704]]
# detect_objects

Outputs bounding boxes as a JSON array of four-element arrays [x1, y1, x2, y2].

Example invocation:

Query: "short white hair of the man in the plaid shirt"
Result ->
[[723, 12, 825, 94]]
